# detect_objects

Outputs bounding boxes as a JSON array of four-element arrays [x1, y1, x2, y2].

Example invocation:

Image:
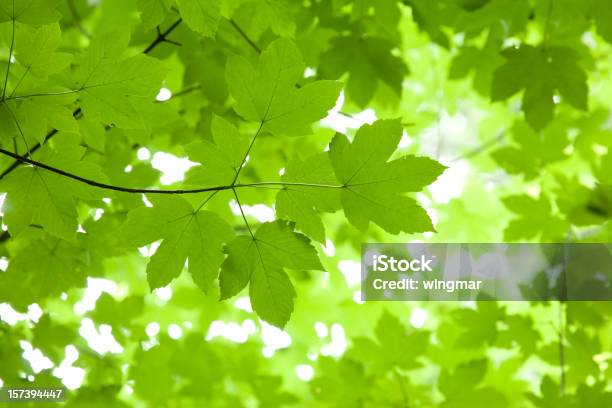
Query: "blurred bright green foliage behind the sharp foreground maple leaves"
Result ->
[[0, 0, 612, 408]]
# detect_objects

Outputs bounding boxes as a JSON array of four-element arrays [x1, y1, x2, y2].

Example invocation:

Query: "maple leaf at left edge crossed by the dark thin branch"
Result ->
[[0, 145, 108, 240]]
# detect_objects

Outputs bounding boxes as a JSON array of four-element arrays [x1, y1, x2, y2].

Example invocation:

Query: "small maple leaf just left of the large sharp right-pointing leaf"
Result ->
[[276, 153, 341, 243]]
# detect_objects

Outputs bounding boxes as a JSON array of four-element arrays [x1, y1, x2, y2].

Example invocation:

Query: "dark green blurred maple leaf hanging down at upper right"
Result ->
[[491, 44, 588, 130]]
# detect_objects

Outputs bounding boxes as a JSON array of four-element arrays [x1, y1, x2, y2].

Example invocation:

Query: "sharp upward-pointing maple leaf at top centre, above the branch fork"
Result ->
[[226, 39, 341, 136]]
